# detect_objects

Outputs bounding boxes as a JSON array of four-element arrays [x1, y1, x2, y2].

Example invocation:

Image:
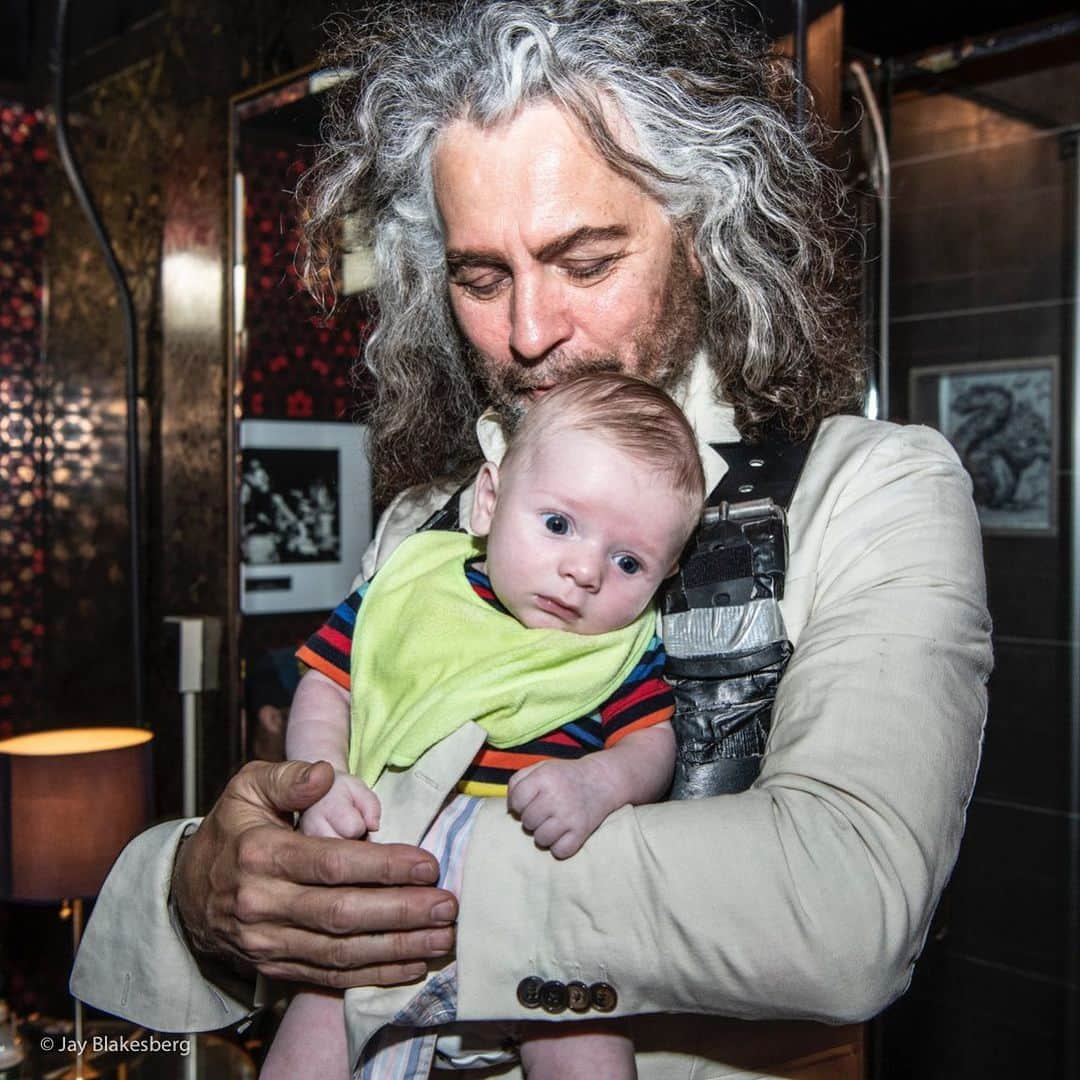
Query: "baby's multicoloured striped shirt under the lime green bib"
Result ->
[[297, 559, 675, 795]]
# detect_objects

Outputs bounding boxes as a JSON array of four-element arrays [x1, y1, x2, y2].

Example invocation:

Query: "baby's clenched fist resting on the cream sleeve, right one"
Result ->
[[507, 761, 615, 859]]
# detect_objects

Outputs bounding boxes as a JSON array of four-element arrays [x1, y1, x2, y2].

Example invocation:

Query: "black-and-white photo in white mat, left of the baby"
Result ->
[[240, 420, 372, 615]]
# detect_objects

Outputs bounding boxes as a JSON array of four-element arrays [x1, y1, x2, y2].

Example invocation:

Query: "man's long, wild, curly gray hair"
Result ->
[[301, 0, 864, 498]]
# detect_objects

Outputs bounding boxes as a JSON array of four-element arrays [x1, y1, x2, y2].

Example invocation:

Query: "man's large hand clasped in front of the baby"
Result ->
[[173, 761, 457, 989]]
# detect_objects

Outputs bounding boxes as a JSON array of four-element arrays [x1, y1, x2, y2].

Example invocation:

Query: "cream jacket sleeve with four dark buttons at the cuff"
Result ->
[[458, 421, 990, 1023]]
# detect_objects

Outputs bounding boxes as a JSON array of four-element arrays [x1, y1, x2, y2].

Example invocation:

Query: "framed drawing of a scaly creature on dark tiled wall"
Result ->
[[909, 356, 1059, 536]]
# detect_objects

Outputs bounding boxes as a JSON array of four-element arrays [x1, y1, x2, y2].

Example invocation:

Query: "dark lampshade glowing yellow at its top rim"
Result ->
[[0, 728, 153, 901]]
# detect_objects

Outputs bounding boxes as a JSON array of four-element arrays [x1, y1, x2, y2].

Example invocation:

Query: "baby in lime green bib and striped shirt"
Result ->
[[262, 374, 704, 1080]]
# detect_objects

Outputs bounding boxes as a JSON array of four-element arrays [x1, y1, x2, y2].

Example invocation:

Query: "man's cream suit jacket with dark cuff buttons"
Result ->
[[71, 380, 990, 1080]]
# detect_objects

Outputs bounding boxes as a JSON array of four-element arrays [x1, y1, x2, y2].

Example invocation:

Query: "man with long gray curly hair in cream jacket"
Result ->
[[72, 0, 990, 1078]]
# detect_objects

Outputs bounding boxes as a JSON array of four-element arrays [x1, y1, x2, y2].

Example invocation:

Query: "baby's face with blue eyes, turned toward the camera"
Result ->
[[472, 431, 698, 634]]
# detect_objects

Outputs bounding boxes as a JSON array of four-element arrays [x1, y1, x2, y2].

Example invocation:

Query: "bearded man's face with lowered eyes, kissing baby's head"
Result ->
[[435, 102, 700, 418]]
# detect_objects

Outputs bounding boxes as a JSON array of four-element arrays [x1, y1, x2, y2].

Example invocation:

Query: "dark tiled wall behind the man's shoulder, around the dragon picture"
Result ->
[[883, 59, 1080, 1080]]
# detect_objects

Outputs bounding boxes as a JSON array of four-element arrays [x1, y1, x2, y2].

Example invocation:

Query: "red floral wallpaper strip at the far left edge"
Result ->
[[0, 102, 49, 738]]
